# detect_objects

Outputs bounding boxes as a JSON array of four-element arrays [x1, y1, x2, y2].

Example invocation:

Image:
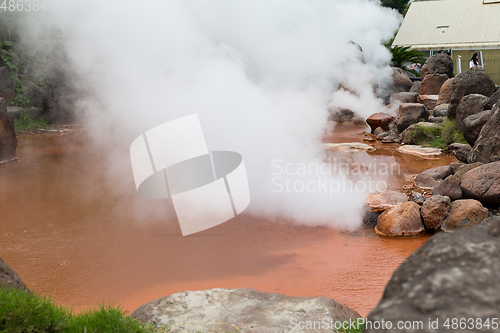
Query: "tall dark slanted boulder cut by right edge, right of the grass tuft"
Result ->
[[468, 103, 500, 163]]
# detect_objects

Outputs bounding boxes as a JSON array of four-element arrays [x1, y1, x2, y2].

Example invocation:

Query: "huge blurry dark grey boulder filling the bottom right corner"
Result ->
[[364, 218, 500, 333]]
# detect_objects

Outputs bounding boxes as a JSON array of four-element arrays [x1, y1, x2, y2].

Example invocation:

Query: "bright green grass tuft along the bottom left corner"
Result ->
[[0, 287, 168, 333]]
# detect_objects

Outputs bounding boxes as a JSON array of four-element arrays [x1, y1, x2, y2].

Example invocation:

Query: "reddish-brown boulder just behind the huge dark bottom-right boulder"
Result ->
[[441, 199, 488, 231]]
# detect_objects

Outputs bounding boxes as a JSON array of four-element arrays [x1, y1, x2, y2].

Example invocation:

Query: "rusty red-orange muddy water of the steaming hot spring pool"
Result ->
[[0, 125, 454, 316]]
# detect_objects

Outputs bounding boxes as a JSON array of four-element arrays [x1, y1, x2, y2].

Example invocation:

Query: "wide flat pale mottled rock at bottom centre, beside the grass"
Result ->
[[131, 288, 360, 333]]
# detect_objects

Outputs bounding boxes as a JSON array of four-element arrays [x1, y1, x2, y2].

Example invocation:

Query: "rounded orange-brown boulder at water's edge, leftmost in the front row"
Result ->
[[375, 201, 425, 237]]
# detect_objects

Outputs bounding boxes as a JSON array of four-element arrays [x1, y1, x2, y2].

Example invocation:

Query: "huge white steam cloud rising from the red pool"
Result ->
[[21, 0, 400, 228]]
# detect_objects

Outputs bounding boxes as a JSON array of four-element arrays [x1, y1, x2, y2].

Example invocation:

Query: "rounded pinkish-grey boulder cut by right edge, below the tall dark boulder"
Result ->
[[460, 162, 500, 205]]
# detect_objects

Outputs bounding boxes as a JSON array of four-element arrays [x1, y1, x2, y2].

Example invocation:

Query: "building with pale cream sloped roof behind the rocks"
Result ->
[[393, 0, 500, 85]]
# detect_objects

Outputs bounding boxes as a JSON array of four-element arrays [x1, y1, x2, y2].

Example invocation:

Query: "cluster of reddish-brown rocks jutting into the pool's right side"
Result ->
[[365, 162, 500, 236]]
